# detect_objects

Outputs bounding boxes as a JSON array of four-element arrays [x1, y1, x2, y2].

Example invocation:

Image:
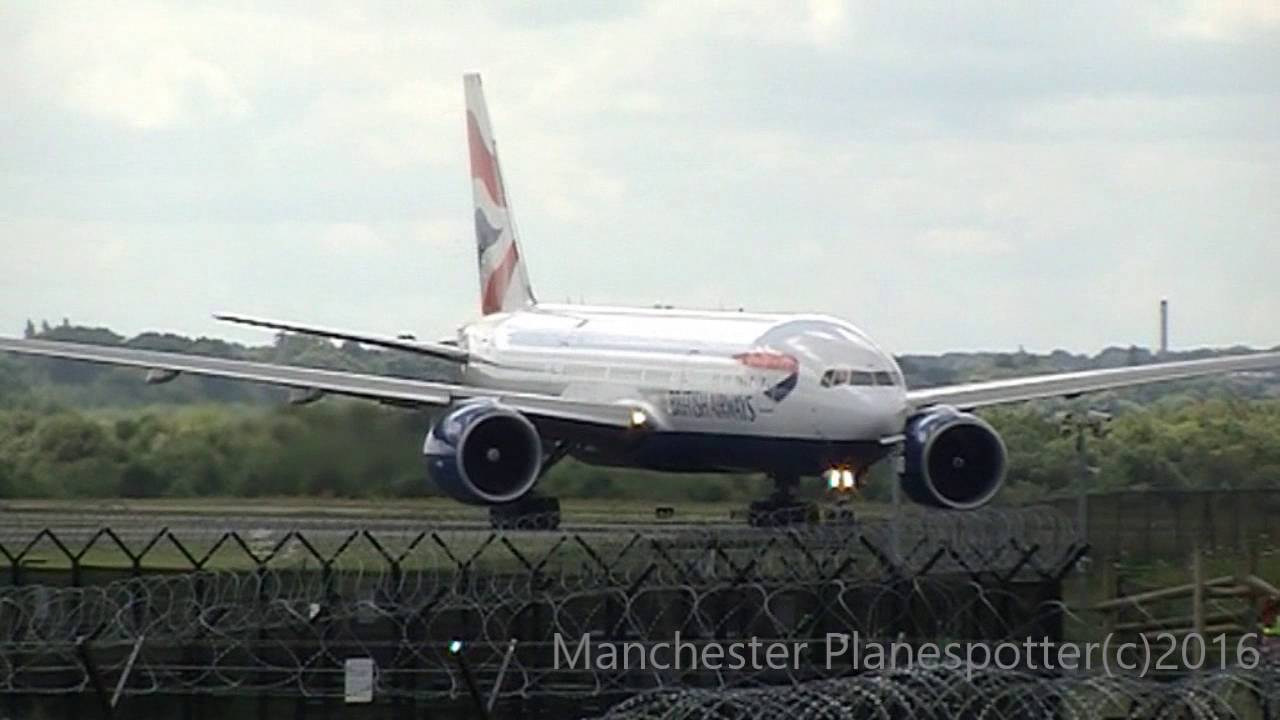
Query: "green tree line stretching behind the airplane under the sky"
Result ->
[[0, 323, 1280, 501]]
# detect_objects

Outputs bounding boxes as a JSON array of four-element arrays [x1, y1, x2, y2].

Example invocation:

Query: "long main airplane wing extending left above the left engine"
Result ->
[[0, 337, 635, 428]]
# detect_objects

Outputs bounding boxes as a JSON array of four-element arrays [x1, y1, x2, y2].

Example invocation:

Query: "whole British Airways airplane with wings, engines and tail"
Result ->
[[0, 74, 1280, 528]]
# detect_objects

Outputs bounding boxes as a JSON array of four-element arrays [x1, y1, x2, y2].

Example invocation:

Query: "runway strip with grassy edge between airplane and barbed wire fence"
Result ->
[[0, 491, 1076, 562]]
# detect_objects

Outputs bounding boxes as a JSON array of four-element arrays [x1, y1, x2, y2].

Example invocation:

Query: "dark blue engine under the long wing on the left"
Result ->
[[422, 400, 543, 505]]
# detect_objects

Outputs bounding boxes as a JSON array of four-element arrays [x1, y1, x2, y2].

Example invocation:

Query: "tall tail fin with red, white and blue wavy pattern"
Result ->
[[462, 73, 534, 315]]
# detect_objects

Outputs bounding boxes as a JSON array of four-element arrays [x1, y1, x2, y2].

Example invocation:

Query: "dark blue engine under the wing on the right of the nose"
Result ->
[[901, 406, 1007, 510]]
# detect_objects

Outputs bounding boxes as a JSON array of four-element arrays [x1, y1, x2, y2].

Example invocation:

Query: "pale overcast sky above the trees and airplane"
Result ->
[[0, 0, 1280, 352]]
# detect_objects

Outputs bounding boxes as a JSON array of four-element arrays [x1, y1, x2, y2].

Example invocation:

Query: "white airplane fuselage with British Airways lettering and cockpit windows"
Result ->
[[458, 305, 906, 469]]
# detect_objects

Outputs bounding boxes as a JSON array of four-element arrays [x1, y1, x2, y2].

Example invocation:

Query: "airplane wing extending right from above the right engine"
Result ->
[[906, 352, 1280, 409]]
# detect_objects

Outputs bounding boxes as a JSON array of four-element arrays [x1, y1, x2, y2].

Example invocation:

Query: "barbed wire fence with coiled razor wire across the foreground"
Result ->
[[0, 509, 1280, 719]]
